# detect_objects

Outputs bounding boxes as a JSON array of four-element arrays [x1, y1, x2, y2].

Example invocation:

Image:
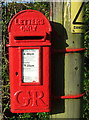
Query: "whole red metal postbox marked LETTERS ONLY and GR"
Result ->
[[7, 10, 51, 113]]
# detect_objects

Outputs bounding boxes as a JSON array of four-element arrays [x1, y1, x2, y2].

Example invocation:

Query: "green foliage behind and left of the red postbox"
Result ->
[[2, 2, 49, 120]]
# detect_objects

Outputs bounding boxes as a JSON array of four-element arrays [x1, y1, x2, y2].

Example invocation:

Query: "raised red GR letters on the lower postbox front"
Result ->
[[14, 90, 46, 107]]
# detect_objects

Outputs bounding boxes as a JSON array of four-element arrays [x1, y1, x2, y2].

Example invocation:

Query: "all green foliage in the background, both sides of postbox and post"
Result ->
[[2, 2, 89, 120]]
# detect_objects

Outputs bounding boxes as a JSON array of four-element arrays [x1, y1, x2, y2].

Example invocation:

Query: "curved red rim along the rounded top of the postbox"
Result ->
[[8, 9, 52, 32]]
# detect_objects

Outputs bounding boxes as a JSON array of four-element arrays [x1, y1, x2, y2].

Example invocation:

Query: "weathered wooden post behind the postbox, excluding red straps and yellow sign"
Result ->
[[50, 0, 84, 120]]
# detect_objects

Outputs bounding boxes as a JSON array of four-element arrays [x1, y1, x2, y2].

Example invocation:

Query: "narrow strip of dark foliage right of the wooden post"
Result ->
[[84, 2, 89, 119]]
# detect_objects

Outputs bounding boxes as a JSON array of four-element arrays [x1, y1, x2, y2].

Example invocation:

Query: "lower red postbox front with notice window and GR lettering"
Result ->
[[9, 47, 50, 113]]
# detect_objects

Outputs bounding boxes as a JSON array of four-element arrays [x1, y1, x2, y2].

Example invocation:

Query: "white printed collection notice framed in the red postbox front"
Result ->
[[22, 49, 39, 83]]
